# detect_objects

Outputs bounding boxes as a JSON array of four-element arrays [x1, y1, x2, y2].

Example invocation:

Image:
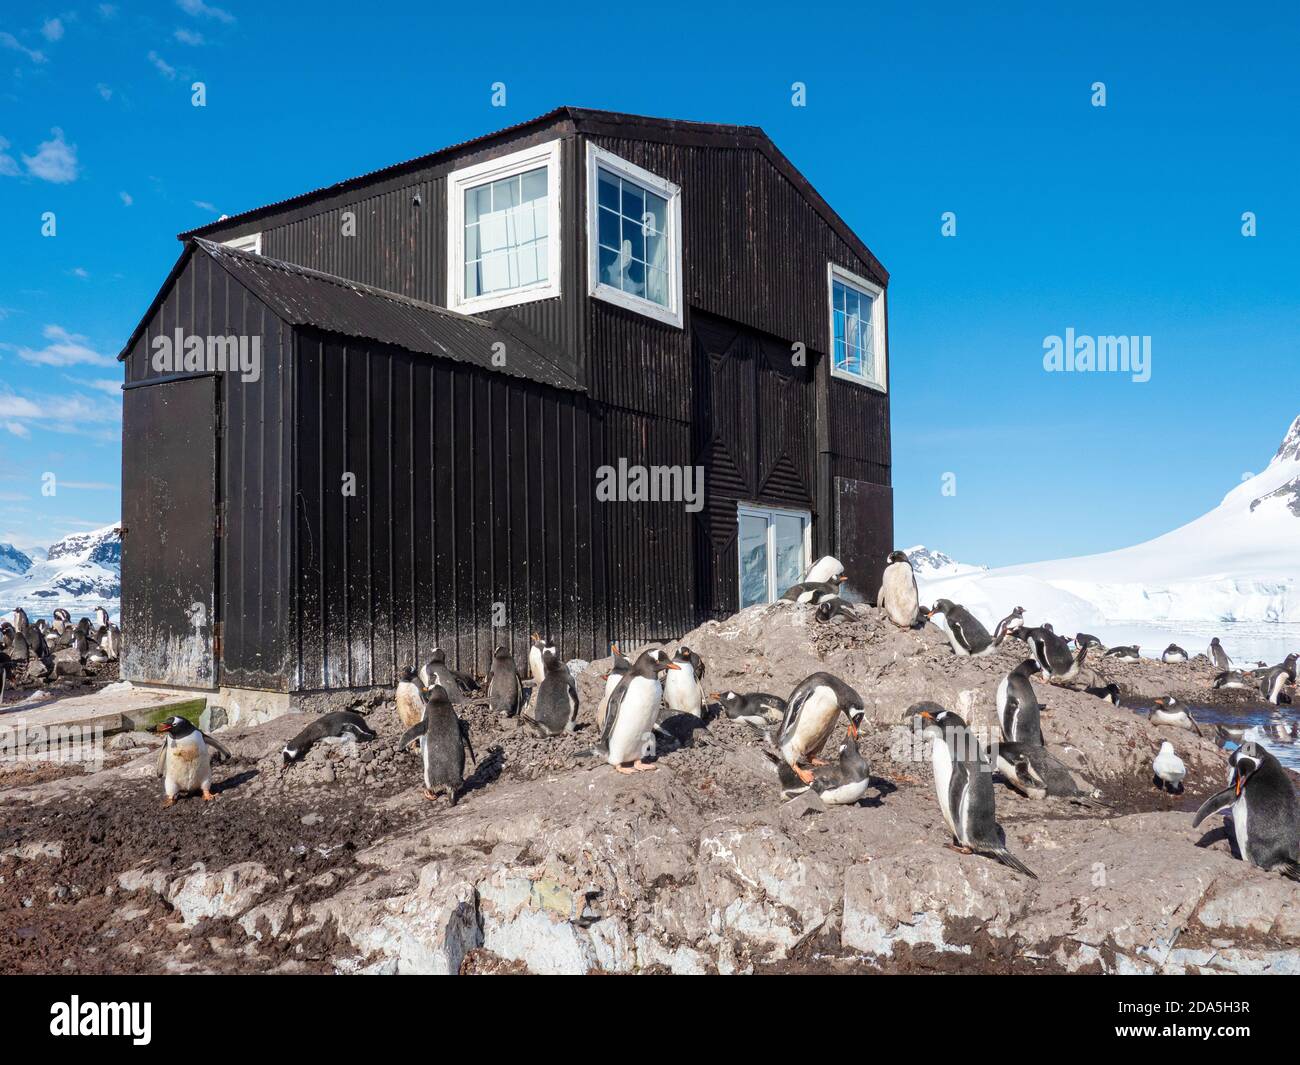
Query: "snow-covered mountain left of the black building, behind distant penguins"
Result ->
[[0, 525, 122, 618]]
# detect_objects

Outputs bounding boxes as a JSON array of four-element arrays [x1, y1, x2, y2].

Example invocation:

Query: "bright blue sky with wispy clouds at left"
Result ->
[[0, 0, 1300, 564]]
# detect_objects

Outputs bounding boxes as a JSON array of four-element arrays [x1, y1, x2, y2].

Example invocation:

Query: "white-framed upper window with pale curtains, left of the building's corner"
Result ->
[[447, 140, 560, 313]]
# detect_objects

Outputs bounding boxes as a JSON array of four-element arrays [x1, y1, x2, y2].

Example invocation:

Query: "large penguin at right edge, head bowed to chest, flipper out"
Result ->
[[1192, 743, 1300, 880]]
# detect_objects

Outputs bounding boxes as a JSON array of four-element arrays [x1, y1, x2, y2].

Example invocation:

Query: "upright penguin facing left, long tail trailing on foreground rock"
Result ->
[[907, 702, 1037, 880]]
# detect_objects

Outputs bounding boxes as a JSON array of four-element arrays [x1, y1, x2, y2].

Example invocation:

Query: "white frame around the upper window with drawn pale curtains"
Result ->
[[447, 140, 563, 315]]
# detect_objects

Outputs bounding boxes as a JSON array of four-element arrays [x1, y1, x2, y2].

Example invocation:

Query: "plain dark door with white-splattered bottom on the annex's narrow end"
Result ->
[[122, 377, 218, 688]]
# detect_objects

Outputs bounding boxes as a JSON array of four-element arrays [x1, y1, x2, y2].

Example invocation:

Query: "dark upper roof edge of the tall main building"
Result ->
[[178, 107, 889, 283]]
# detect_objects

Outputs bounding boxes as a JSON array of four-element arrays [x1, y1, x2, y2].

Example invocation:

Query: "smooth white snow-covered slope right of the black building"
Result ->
[[918, 417, 1300, 632]]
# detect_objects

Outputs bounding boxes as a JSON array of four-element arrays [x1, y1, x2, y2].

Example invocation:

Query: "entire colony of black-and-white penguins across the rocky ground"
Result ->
[[15, 551, 1300, 879]]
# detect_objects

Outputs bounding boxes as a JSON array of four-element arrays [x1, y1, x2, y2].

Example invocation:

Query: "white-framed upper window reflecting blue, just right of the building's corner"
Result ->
[[586, 144, 681, 329]]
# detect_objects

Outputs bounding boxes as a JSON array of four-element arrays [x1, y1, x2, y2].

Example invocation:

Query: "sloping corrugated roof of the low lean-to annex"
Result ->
[[117, 238, 582, 391]]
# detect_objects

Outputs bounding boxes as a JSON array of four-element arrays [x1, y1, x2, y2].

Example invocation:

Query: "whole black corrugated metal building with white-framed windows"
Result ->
[[120, 108, 893, 693]]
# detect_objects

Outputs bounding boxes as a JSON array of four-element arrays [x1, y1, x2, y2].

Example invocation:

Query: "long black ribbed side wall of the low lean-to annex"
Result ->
[[294, 329, 607, 689]]
